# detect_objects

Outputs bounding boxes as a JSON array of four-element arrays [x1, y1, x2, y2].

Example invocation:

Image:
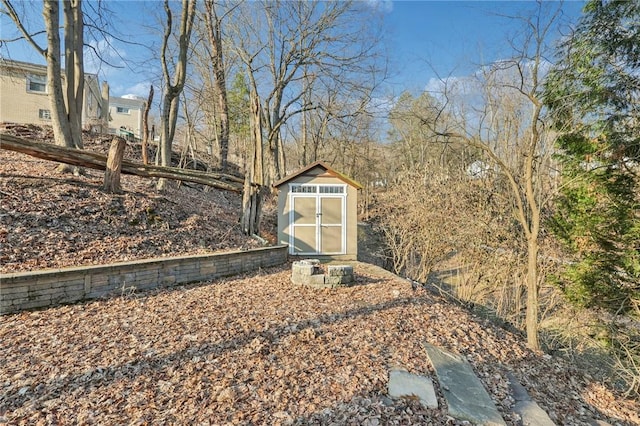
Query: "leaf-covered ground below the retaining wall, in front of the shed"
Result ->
[[0, 264, 639, 425]]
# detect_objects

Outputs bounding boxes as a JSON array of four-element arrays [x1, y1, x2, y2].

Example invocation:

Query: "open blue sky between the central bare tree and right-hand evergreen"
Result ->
[[387, 1, 584, 93]]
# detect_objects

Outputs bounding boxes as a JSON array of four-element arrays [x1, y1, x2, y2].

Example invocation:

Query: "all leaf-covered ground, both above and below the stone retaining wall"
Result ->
[[0, 128, 640, 425]]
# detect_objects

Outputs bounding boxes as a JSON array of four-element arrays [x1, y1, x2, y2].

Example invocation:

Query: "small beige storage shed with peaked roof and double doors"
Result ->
[[274, 161, 362, 260]]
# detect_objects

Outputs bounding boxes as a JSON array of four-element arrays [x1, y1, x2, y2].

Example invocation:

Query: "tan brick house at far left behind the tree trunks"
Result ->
[[0, 58, 104, 130]]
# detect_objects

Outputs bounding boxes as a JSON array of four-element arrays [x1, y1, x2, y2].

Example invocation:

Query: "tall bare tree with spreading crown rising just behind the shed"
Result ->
[[233, 1, 378, 185]]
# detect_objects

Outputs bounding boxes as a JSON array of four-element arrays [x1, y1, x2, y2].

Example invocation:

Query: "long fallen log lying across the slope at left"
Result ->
[[0, 133, 244, 193]]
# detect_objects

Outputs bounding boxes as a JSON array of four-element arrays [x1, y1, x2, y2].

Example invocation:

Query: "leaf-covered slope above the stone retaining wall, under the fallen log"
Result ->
[[0, 126, 276, 273]]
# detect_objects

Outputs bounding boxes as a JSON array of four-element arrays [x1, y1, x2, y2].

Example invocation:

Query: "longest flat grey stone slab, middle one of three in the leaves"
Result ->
[[425, 343, 506, 426]]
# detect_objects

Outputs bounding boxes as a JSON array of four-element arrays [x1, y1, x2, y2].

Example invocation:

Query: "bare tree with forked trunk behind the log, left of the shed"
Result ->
[[158, 0, 196, 189]]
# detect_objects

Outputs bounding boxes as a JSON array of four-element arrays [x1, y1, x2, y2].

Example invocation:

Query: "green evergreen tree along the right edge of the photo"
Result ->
[[545, 0, 640, 316]]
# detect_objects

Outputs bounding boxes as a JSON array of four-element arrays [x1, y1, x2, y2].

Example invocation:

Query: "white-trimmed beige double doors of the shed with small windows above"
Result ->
[[289, 185, 346, 254]]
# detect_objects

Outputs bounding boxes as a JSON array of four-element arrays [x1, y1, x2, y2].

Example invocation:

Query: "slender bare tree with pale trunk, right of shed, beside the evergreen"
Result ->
[[412, 3, 560, 349]]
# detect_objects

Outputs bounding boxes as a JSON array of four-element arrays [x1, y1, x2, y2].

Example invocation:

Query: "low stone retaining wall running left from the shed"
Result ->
[[0, 245, 287, 314]]
